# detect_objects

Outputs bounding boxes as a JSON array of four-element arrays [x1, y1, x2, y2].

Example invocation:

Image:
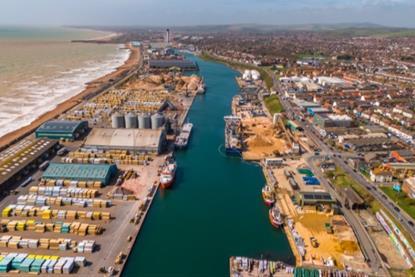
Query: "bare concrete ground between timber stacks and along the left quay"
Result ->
[[0, 153, 164, 275]]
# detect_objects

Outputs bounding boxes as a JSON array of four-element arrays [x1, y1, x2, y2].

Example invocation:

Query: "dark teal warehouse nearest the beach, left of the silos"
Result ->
[[35, 120, 88, 140]]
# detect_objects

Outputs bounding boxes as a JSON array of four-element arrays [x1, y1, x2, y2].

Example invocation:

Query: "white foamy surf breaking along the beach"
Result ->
[[0, 45, 130, 136]]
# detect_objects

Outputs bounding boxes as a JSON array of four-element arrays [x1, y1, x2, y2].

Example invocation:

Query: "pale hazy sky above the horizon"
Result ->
[[0, 0, 415, 27]]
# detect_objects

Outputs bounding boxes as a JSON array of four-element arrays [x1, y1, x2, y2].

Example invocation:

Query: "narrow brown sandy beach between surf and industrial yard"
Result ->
[[0, 44, 141, 149]]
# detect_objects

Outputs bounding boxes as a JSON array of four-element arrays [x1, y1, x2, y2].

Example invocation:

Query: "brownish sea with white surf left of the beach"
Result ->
[[0, 26, 130, 137]]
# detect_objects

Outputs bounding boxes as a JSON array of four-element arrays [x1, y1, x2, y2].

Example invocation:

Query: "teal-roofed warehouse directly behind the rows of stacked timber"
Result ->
[[42, 163, 117, 185]]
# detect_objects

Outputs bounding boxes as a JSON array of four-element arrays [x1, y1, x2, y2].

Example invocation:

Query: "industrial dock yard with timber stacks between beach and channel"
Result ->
[[0, 37, 204, 276]]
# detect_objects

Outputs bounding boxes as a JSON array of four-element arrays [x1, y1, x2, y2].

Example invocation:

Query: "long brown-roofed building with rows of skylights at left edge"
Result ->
[[0, 139, 59, 188]]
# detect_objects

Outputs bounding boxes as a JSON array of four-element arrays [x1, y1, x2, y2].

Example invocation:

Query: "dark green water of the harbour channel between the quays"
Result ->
[[123, 56, 294, 276]]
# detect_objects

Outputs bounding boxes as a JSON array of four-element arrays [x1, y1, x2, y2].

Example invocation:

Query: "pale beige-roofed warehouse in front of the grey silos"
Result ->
[[84, 128, 166, 154]]
